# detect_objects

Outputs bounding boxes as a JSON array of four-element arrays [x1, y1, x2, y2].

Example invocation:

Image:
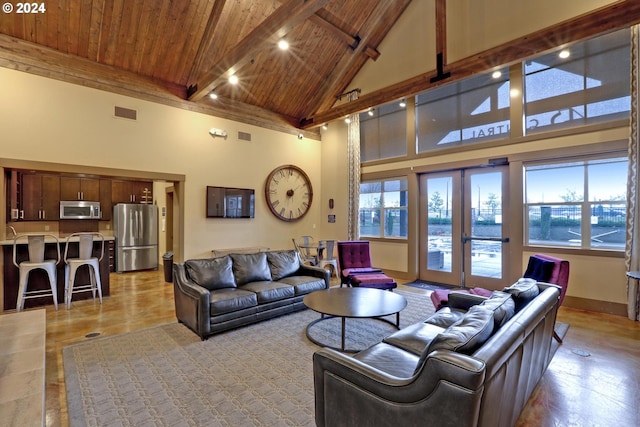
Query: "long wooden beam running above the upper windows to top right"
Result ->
[[300, 0, 640, 129]]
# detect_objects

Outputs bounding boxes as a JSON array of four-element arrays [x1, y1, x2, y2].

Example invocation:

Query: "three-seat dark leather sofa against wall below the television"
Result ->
[[173, 250, 330, 340]]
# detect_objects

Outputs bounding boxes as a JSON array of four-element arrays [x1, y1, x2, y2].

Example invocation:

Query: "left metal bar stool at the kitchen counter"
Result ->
[[13, 234, 60, 311]]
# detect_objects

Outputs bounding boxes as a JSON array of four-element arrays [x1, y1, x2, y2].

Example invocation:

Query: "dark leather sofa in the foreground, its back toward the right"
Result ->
[[313, 279, 560, 427]]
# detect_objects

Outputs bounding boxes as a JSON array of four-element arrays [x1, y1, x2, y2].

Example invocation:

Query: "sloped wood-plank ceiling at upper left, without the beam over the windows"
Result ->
[[0, 0, 411, 137]]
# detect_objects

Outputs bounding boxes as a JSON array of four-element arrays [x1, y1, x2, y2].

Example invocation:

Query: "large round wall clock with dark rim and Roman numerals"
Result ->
[[264, 165, 313, 221]]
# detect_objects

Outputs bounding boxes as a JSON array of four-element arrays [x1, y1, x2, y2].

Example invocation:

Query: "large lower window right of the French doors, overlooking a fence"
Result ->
[[525, 156, 627, 251]]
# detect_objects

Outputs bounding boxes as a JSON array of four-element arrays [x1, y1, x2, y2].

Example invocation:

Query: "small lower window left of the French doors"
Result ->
[[360, 179, 407, 238]]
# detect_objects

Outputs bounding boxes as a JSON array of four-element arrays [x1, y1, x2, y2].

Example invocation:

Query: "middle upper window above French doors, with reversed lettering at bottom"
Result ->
[[416, 69, 510, 153]]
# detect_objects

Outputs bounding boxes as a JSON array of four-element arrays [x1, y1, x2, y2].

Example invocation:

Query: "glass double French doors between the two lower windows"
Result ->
[[419, 166, 509, 289]]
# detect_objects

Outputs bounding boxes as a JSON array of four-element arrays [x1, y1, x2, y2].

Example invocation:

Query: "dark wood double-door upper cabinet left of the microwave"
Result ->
[[20, 174, 60, 221]]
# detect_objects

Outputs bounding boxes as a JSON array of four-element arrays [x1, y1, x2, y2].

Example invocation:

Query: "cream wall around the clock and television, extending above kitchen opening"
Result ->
[[0, 68, 324, 258]]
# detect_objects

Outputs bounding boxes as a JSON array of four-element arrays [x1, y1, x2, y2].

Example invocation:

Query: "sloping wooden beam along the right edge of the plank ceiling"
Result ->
[[303, 0, 411, 124]]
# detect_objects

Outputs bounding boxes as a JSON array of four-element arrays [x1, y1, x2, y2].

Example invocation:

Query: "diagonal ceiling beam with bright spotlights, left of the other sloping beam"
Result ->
[[189, 0, 328, 101]]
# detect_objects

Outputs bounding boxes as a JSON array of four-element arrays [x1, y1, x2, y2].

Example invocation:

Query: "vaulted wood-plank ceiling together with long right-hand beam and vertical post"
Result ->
[[0, 0, 640, 137]]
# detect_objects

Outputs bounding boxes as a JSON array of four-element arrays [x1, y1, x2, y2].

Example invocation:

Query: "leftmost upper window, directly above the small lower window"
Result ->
[[360, 102, 407, 162]]
